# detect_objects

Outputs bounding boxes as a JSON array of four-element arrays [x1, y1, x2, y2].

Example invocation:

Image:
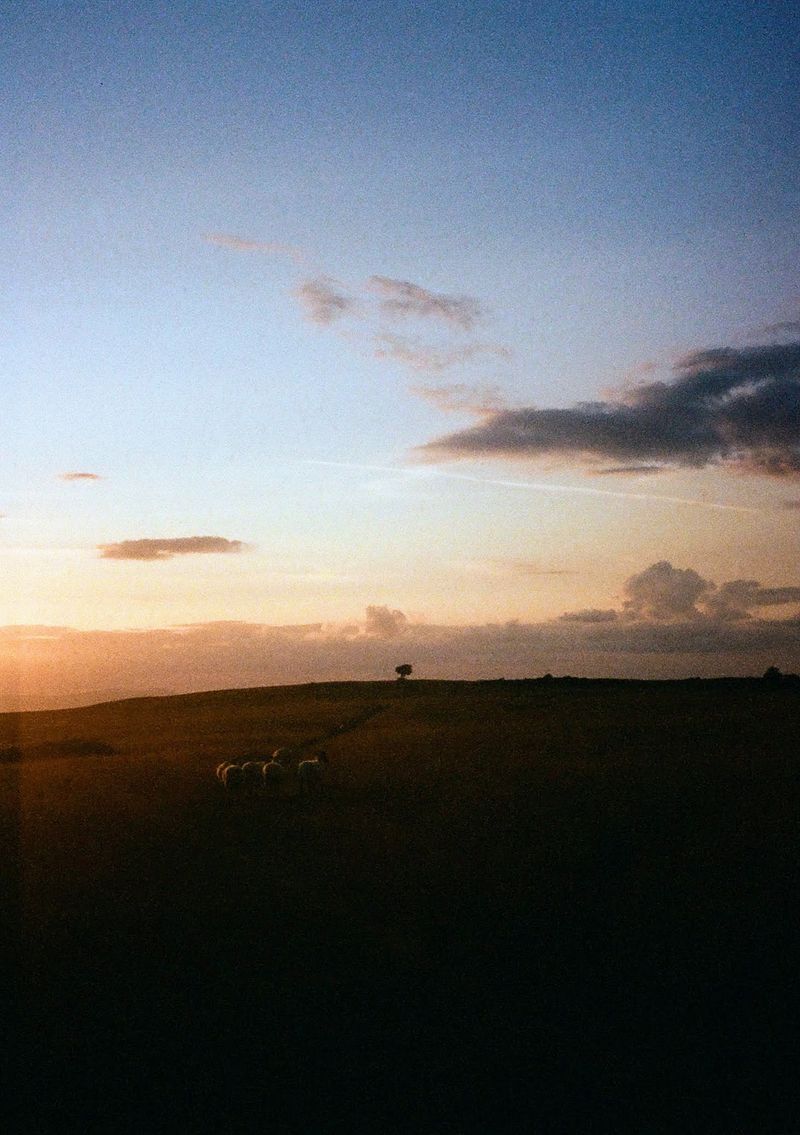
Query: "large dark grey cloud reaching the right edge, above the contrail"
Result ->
[[418, 342, 800, 478]]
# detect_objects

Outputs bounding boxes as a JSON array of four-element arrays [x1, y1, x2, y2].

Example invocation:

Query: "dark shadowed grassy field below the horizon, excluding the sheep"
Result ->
[[0, 680, 800, 1135]]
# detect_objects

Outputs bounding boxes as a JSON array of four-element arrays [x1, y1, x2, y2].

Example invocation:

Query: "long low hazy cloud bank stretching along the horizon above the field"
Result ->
[[9, 594, 800, 712]]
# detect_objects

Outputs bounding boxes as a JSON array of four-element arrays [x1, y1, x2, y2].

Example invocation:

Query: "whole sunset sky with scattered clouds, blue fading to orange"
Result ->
[[0, 0, 800, 708]]
